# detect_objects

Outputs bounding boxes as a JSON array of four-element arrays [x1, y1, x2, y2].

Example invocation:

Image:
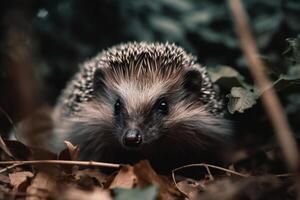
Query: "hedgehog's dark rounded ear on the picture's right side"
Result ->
[[183, 69, 202, 94]]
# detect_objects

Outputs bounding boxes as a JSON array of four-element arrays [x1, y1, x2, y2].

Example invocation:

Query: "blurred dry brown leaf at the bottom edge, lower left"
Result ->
[[26, 172, 56, 200]]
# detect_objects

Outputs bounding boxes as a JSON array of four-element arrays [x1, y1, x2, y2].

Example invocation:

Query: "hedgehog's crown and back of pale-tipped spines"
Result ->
[[56, 42, 223, 117]]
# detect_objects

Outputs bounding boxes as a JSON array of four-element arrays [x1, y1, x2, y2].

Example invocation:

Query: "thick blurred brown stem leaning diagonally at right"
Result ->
[[228, 0, 298, 170]]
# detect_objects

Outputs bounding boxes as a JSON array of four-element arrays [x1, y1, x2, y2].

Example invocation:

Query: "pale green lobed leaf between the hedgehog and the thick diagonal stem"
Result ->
[[227, 87, 258, 114]]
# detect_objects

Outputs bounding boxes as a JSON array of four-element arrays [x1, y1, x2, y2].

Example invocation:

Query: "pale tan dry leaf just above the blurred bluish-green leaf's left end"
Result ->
[[109, 165, 137, 189]]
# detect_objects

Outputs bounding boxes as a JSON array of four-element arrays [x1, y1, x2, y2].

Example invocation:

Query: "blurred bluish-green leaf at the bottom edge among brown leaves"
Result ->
[[113, 186, 158, 200]]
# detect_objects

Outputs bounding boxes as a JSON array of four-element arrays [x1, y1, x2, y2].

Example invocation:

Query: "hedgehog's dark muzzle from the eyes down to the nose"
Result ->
[[113, 97, 169, 148]]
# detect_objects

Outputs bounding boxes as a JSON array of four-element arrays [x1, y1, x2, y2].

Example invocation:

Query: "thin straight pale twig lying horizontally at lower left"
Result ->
[[0, 160, 122, 173]]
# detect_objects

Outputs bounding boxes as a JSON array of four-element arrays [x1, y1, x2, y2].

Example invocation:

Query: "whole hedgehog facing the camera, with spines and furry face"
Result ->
[[49, 42, 231, 172]]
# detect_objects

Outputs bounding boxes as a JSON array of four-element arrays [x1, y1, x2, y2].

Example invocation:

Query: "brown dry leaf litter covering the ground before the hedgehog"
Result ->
[[0, 134, 296, 200]]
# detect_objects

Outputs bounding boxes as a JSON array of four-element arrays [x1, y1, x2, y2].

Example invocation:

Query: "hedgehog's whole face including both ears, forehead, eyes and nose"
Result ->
[[94, 64, 212, 149]]
